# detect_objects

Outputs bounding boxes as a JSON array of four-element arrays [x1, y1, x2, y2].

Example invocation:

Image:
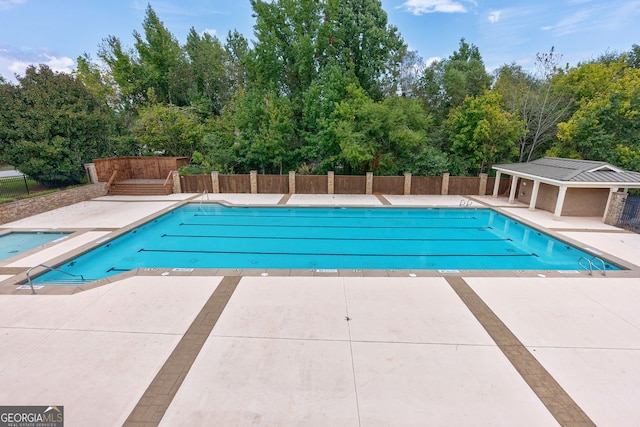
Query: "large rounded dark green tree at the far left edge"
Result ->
[[0, 65, 113, 186]]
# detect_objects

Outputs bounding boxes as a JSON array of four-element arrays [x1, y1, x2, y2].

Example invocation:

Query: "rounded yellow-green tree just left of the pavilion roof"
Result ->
[[446, 91, 525, 175]]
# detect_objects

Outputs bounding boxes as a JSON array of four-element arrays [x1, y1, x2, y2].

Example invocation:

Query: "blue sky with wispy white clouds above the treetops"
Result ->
[[0, 0, 640, 80]]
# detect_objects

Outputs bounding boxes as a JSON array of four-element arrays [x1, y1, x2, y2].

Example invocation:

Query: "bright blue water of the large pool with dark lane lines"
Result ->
[[33, 205, 619, 282]]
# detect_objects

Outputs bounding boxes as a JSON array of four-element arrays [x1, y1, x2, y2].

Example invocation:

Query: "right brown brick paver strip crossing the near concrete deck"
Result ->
[[445, 277, 596, 426]]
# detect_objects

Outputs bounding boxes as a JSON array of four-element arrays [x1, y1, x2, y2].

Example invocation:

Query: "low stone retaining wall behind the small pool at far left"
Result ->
[[0, 183, 107, 224]]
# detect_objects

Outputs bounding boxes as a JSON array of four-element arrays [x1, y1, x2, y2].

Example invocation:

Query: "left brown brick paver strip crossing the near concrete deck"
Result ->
[[123, 276, 242, 427]]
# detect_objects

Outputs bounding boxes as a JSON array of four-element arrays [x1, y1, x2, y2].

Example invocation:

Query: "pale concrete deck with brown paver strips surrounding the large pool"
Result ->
[[0, 194, 640, 426]]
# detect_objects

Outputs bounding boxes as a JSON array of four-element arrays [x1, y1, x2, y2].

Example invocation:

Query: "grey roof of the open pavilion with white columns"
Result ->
[[493, 157, 640, 185]]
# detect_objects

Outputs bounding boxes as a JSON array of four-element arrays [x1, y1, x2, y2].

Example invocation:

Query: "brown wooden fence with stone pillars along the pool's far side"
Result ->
[[180, 172, 510, 195]]
